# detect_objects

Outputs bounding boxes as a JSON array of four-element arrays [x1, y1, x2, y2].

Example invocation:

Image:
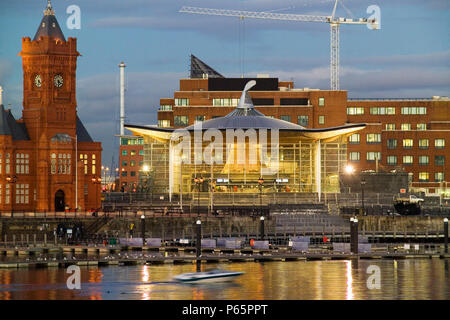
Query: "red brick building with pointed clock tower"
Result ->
[[0, 3, 102, 211]]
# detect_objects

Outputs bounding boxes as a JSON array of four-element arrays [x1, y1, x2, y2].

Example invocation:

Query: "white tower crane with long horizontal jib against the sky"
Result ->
[[179, 0, 378, 90]]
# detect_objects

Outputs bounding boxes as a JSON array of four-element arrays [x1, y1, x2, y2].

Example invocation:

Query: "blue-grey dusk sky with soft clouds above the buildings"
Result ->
[[0, 0, 450, 166]]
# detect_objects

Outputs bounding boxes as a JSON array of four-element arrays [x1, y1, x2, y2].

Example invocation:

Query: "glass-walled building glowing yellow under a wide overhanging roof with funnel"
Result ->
[[126, 81, 365, 198]]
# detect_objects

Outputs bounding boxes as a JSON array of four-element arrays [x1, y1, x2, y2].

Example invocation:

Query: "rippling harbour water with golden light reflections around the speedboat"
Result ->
[[0, 259, 450, 300]]
